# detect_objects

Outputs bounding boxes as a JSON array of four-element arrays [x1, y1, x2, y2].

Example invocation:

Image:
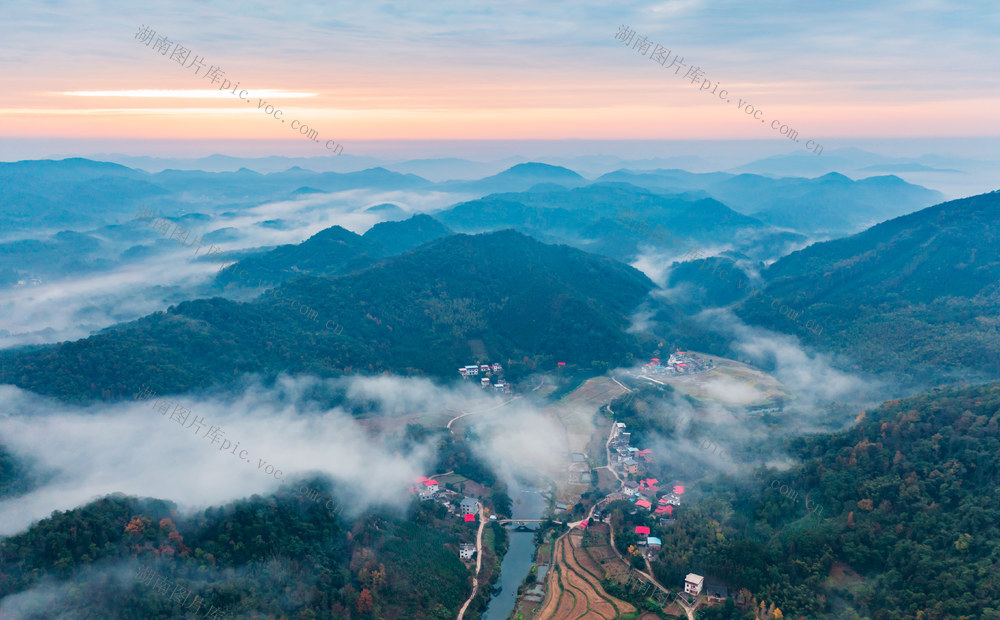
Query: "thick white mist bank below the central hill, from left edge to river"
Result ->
[[0, 375, 572, 535]]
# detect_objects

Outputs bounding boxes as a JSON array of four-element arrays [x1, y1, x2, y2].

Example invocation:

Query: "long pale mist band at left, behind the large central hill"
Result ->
[[0, 189, 455, 348]]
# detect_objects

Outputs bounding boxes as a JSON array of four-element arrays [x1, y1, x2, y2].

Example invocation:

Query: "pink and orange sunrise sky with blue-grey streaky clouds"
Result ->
[[0, 0, 1000, 155]]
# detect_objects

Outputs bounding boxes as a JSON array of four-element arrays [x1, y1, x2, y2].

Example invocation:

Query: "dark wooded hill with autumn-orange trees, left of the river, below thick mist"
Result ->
[[0, 489, 474, 620]]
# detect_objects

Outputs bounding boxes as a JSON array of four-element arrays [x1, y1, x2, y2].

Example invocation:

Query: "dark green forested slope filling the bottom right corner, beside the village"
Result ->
[[656, 383, 1000, 620]]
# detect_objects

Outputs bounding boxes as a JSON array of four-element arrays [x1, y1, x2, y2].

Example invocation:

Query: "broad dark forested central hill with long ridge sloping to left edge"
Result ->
[[0, 231, 653, 401]]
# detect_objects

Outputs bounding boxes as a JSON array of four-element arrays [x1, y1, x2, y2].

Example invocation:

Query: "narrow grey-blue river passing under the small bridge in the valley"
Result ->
[[483, 484, 549, 620]]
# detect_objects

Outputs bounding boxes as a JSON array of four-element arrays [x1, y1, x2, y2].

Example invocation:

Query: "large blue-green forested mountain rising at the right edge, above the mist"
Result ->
[[738, 192, 1000, 383]]
